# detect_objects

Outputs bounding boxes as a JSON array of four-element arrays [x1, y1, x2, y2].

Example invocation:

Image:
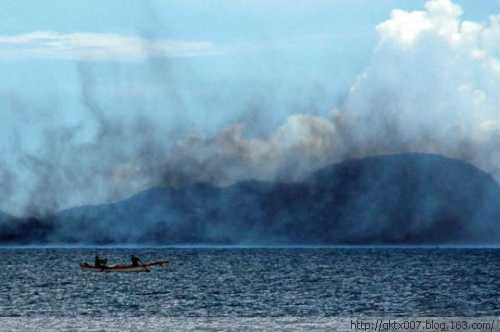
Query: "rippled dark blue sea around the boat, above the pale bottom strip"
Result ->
[[0, 248, 500, 317]]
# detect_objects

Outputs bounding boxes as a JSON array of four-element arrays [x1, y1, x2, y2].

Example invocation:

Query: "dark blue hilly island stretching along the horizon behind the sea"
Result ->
[[0, 153, 500, 245]]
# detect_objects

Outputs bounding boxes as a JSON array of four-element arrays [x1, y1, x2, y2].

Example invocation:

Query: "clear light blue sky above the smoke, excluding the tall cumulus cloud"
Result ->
[[0, 0, 500, 136]]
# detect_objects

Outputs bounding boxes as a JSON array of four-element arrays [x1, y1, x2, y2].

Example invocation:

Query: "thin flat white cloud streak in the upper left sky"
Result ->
[[0, 31, 218, 61]]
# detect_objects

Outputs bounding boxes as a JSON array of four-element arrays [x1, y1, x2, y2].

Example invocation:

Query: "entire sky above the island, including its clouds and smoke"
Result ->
[[0, 0, 500, 214]]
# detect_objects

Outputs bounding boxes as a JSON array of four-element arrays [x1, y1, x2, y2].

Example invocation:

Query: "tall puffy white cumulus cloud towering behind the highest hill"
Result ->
[[344, 0, 500, 176]]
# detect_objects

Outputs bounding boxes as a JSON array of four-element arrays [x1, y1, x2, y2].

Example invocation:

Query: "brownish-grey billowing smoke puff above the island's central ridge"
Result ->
[[161, 114, 336, 185]]
